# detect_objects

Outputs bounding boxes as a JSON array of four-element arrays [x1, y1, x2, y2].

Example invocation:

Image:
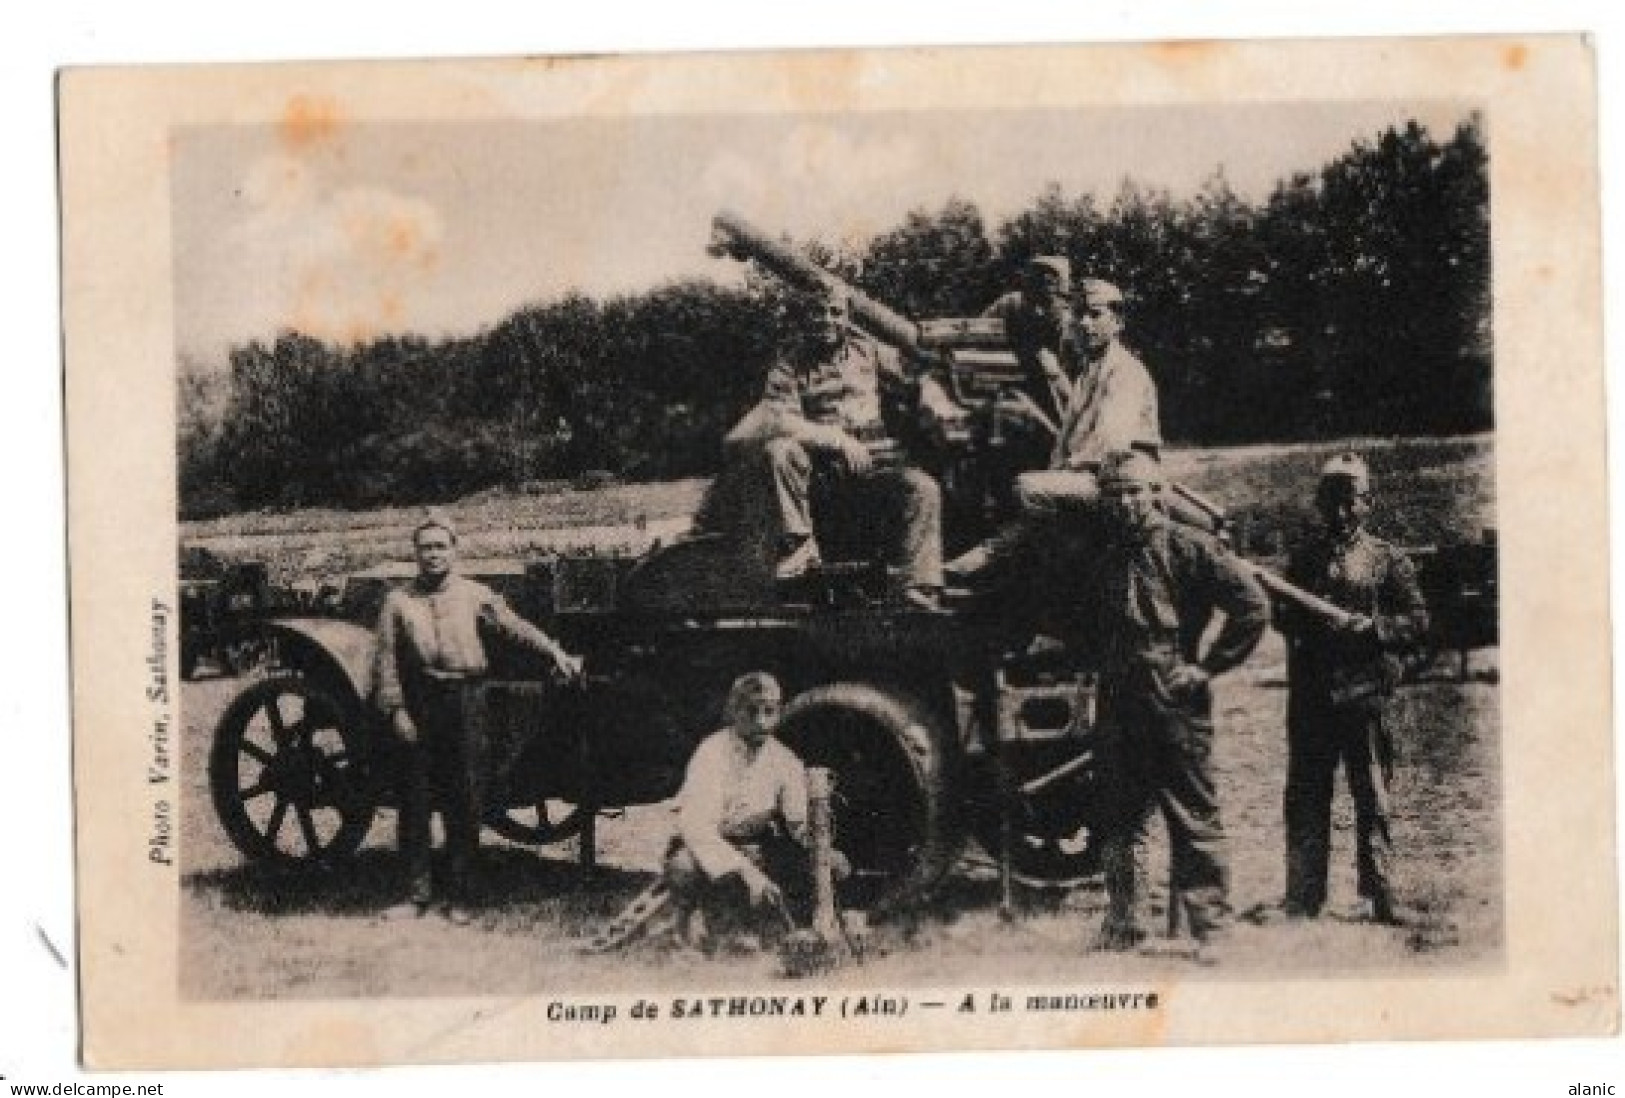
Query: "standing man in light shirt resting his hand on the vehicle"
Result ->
[[374, 515, 582, 924]]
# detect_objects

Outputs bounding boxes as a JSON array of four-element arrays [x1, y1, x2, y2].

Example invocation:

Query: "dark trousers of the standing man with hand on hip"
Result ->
[[1100, 684, 1230, 940]]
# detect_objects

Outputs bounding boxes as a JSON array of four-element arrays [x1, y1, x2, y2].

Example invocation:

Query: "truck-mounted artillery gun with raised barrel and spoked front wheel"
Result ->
[[210, 214, 1352, 910]]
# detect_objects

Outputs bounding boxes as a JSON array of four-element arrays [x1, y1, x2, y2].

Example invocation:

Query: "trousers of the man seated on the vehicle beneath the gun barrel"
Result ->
[[696, 439, 943, 586]]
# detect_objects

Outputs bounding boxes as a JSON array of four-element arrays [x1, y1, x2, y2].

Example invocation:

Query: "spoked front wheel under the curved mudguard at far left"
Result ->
[[210, 676, 377, 867]]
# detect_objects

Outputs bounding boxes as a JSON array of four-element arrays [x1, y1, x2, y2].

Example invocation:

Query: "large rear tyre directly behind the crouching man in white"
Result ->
[[782, 682, 962, 910]]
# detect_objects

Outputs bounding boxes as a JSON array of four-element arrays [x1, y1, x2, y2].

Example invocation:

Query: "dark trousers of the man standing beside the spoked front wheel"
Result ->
[[398, 676, 486, 903]]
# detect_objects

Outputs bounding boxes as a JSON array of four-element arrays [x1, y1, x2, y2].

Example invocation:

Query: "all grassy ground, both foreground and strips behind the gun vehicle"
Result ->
[[180, 439, 1503, 1000]]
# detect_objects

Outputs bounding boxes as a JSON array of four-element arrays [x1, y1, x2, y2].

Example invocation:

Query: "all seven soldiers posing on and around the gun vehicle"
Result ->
[[365, 257, 1427, 960]]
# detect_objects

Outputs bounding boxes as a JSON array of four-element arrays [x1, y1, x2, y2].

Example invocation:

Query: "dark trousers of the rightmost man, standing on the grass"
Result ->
[[1285, 687, 1394, 913]]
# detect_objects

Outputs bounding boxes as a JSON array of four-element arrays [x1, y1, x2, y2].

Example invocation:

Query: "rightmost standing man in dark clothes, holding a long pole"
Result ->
[[1277, 453, 1427, 924]]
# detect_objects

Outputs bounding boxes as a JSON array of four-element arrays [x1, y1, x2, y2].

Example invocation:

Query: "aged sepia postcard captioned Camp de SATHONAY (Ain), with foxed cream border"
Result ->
[[60, 37, 1619, 1067]]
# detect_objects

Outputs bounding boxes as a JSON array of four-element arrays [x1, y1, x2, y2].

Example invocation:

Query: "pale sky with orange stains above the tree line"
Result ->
[[174, 102, 1471, 364]]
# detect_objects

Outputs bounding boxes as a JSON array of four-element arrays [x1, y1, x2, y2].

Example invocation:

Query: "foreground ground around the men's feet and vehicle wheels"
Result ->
[[180, 635, 1503, 999]]
